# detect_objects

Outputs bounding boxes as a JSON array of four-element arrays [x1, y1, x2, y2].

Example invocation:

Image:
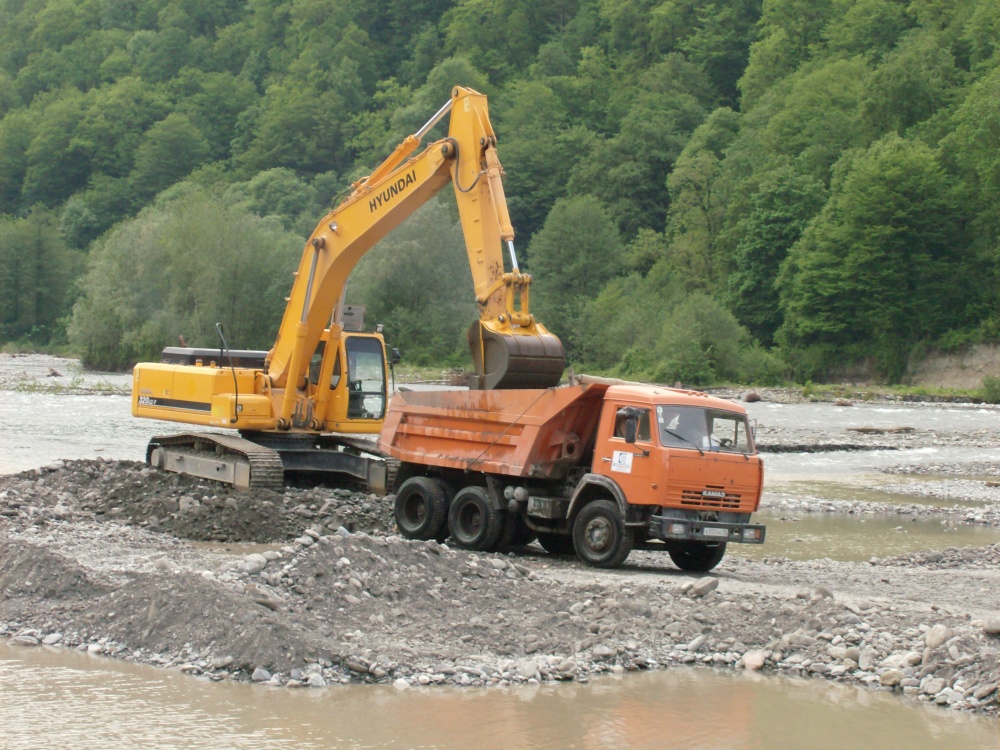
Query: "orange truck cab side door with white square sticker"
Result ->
[[593, 403, 657, 502]]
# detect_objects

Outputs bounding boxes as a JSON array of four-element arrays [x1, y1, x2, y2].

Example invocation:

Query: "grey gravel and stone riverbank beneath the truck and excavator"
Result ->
[[0, 446, 1000, 715]]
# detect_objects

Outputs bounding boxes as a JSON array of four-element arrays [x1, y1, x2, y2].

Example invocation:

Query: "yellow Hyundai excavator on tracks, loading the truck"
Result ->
[[132, 86, 565, 491]]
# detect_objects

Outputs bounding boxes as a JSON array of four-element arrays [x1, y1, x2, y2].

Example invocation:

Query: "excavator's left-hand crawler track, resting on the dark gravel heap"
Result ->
[[146, 432, 284, 492]]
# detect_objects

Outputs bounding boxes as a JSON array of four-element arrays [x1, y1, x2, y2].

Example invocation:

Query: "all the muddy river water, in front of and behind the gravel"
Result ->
[[0, 356, 1000, 750]]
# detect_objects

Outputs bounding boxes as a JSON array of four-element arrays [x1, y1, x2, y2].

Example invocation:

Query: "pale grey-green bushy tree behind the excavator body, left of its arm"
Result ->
[[69, 185, 302, 369]]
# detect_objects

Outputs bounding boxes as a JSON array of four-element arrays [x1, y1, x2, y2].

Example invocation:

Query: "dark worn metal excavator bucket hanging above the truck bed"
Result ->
[[468, 321, 566, 390]]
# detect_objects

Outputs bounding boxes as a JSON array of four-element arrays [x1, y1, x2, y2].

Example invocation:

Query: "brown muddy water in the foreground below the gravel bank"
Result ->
[[0, 644, 996, 750]]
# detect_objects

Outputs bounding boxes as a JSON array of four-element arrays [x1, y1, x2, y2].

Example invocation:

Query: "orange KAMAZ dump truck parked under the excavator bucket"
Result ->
[[379, 377, 765, 571]]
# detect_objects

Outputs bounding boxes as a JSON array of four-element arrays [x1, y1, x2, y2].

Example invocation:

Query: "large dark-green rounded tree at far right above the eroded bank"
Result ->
[[777, 134, 970, 382]]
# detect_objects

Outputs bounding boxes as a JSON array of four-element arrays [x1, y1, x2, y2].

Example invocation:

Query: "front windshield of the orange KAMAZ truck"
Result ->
[[656, 405, 753, 453]]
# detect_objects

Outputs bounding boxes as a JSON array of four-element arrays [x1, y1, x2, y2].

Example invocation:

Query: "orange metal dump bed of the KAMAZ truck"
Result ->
[[379, 383, 608, 479]]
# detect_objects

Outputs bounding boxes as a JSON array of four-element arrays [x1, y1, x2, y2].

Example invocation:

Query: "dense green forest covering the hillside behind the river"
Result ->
[[0, 0, 1000, 385]]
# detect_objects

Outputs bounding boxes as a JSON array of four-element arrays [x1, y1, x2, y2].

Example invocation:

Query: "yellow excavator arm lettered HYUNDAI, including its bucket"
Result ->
[[265, 87, 565, 420]]
